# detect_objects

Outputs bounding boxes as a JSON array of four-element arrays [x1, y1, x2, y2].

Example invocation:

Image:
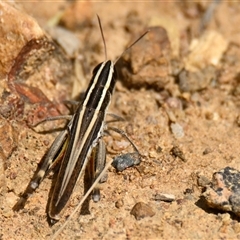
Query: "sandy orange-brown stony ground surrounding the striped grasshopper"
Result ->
[[0, 1, 240, 239]]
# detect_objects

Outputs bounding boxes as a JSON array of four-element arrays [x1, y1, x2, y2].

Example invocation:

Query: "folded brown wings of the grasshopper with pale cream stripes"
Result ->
[[48, 106, 104, 220]]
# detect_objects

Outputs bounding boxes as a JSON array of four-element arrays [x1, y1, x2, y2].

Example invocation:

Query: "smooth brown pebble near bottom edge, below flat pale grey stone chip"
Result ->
[[130, 202, 155, 220]]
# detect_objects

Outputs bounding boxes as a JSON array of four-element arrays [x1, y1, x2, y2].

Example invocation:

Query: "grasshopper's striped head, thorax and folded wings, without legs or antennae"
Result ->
[[49, 61, 116, 219]]
